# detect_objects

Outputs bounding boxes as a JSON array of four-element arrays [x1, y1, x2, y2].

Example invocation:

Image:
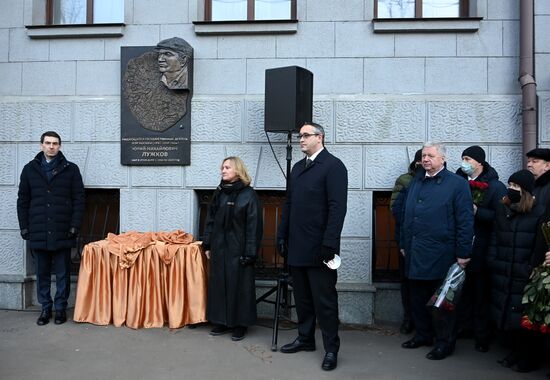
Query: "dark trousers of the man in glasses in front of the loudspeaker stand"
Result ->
[[290, 266, 340, 352]]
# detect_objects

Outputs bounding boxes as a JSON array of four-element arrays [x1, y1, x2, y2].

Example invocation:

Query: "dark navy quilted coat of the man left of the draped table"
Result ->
[[17, 152, 84, 251]]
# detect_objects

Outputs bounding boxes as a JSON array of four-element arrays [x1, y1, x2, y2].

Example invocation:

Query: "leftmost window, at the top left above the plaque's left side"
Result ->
[[46, 0, 124, 25]]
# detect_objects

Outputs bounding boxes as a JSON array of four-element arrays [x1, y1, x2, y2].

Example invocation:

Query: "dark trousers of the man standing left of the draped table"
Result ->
[[33, 248, 71, 310]]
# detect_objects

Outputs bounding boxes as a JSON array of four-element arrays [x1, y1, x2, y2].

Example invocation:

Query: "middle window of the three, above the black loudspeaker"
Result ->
[[205, 0, 296, 21]]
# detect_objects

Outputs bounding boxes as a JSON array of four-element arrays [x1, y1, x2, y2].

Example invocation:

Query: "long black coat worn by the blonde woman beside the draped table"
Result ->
[[203, 187, 263, 327]]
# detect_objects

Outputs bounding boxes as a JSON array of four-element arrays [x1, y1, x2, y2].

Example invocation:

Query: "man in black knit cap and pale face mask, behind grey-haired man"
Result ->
[[456, 145, 506, 352]]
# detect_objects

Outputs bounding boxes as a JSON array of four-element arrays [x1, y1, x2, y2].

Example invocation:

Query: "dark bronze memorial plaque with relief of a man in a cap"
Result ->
[[120, 37, 193, 166]]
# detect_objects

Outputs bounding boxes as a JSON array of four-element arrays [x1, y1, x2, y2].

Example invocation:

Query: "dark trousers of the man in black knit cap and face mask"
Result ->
[[457, 271, 491, 343]]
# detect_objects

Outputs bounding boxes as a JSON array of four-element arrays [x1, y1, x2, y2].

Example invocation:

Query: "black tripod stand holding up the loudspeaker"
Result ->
[[256, 131, 295, 351]]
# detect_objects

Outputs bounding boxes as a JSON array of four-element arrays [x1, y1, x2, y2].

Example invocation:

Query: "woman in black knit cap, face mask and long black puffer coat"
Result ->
[[488, 170, 544, 372]]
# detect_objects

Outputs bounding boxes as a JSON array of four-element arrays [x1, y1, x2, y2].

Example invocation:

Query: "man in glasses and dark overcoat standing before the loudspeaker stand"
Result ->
[[277, 123, 348, 370]]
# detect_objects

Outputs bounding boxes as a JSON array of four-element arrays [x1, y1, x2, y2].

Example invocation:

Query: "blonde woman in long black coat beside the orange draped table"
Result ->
[[203, 157, 263, 341]]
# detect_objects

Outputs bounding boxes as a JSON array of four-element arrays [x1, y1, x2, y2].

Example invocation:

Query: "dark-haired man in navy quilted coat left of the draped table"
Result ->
[[17, 131, 84, 326]]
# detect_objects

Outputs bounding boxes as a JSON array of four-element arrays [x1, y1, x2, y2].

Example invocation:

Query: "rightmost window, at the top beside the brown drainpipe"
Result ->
[[374, 0, 470, 18]]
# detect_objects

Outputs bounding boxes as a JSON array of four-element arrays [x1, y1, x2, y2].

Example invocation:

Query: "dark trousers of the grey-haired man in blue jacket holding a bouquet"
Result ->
[[410, 280, 456, 350]]
